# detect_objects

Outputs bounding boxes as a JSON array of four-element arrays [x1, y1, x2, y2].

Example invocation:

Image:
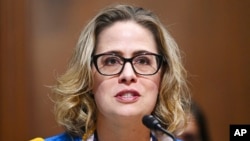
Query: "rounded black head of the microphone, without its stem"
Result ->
[[142, 115, 160, 130]]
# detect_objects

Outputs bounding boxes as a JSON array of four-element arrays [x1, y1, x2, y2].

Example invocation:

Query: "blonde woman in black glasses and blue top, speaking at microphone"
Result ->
[[32, 5, 189, 141]]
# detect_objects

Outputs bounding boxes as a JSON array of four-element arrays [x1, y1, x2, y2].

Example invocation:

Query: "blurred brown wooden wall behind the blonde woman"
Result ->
[[0, 0, 250, 141]]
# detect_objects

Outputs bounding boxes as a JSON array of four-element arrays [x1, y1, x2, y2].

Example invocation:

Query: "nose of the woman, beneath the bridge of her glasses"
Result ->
[[119, 62, 137, 84]]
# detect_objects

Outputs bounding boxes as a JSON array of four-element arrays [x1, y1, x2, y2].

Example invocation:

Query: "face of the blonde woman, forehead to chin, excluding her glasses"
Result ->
[[92, 21, 161, 118]]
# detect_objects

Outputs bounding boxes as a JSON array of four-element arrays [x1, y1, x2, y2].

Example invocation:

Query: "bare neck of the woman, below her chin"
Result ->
[[96, 115, 150, 141]]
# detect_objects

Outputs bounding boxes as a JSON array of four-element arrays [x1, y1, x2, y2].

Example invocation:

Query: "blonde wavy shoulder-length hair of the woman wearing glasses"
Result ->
[[52, 5, 190, 136]]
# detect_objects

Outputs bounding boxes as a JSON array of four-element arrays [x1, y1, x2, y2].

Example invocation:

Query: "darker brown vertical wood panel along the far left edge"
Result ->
[[0, 0, 30, 140]]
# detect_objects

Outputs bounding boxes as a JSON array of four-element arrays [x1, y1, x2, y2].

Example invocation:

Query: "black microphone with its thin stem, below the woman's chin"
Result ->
[[142, 115, 177, 141]]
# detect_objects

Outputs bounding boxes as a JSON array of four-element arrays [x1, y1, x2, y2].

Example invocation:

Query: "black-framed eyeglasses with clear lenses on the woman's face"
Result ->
[[92, 52, 163, 76]]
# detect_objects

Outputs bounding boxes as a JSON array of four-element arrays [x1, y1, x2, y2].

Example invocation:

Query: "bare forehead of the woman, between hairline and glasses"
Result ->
[[96, 21, 157, 54]]
